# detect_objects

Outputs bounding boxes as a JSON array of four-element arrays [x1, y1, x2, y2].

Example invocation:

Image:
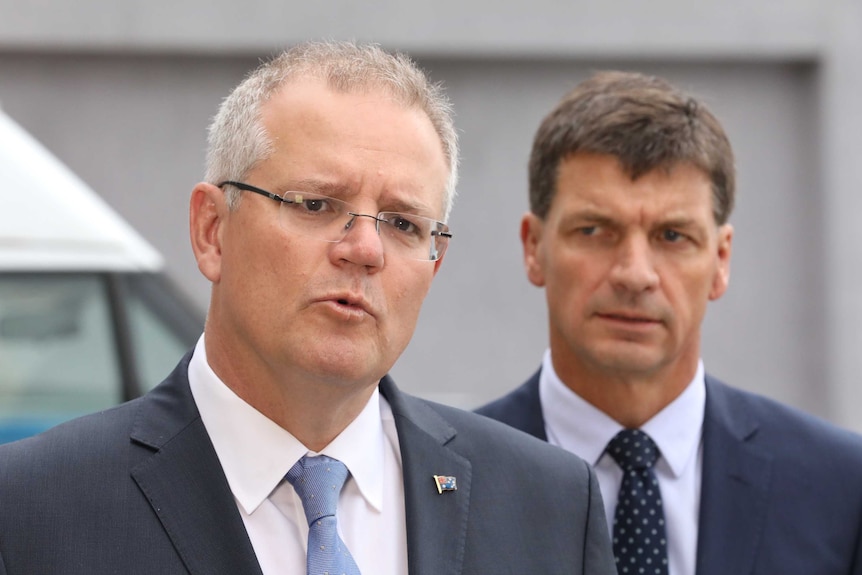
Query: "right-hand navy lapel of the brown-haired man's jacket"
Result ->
[[696, 377, 772, 575]]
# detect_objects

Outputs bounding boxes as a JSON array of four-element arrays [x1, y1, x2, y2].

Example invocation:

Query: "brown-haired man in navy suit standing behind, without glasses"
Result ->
[[479, 72, 862, 575]]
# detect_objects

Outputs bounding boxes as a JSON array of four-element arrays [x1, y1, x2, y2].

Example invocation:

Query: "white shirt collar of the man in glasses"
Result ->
[[189, 336, 385, 514]]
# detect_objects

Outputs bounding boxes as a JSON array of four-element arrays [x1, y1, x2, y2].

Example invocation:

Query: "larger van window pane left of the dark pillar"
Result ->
[[0, 274, 121, 441]]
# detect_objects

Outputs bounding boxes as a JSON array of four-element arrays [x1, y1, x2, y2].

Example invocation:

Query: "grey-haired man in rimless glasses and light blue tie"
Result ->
[[0, 43, 615, 575]]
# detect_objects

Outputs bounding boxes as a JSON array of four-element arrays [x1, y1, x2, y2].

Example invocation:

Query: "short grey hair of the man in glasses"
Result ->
[[206, 42, 458, 221]]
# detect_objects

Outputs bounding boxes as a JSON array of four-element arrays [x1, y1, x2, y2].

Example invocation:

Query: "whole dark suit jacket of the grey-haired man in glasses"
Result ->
[[0, 356, 615, 575]]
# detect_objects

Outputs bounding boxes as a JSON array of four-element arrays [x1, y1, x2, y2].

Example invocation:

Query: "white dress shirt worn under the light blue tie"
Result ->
[[189, 336, 407, 575]]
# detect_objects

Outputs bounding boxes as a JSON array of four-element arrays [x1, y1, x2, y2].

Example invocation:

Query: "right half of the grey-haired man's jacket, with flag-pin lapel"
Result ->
[[381, 378, 616, 575]]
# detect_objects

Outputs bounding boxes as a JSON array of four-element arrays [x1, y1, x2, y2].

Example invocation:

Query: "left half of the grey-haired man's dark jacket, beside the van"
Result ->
[[0, 356, 260, 575]]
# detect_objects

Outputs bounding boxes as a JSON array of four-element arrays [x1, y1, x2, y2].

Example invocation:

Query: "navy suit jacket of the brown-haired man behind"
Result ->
[[478, 372, 862, 575]]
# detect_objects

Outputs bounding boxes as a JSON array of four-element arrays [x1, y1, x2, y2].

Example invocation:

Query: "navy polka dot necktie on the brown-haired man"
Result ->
[[607, 429, 668, 575]]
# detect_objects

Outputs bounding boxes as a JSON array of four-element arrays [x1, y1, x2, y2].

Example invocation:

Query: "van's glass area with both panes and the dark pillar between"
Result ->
[[0, 272, 203, 443]]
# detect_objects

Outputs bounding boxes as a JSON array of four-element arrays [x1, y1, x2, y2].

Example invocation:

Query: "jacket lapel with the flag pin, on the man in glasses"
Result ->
[[380, 376, 472, 575]]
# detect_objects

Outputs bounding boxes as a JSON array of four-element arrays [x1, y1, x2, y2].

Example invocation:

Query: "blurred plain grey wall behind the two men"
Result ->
[[0, 0, 862, 430]]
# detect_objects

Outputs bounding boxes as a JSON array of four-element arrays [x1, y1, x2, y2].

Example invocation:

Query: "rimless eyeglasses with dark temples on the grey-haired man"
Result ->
[[218, 180, 452, 261]]
